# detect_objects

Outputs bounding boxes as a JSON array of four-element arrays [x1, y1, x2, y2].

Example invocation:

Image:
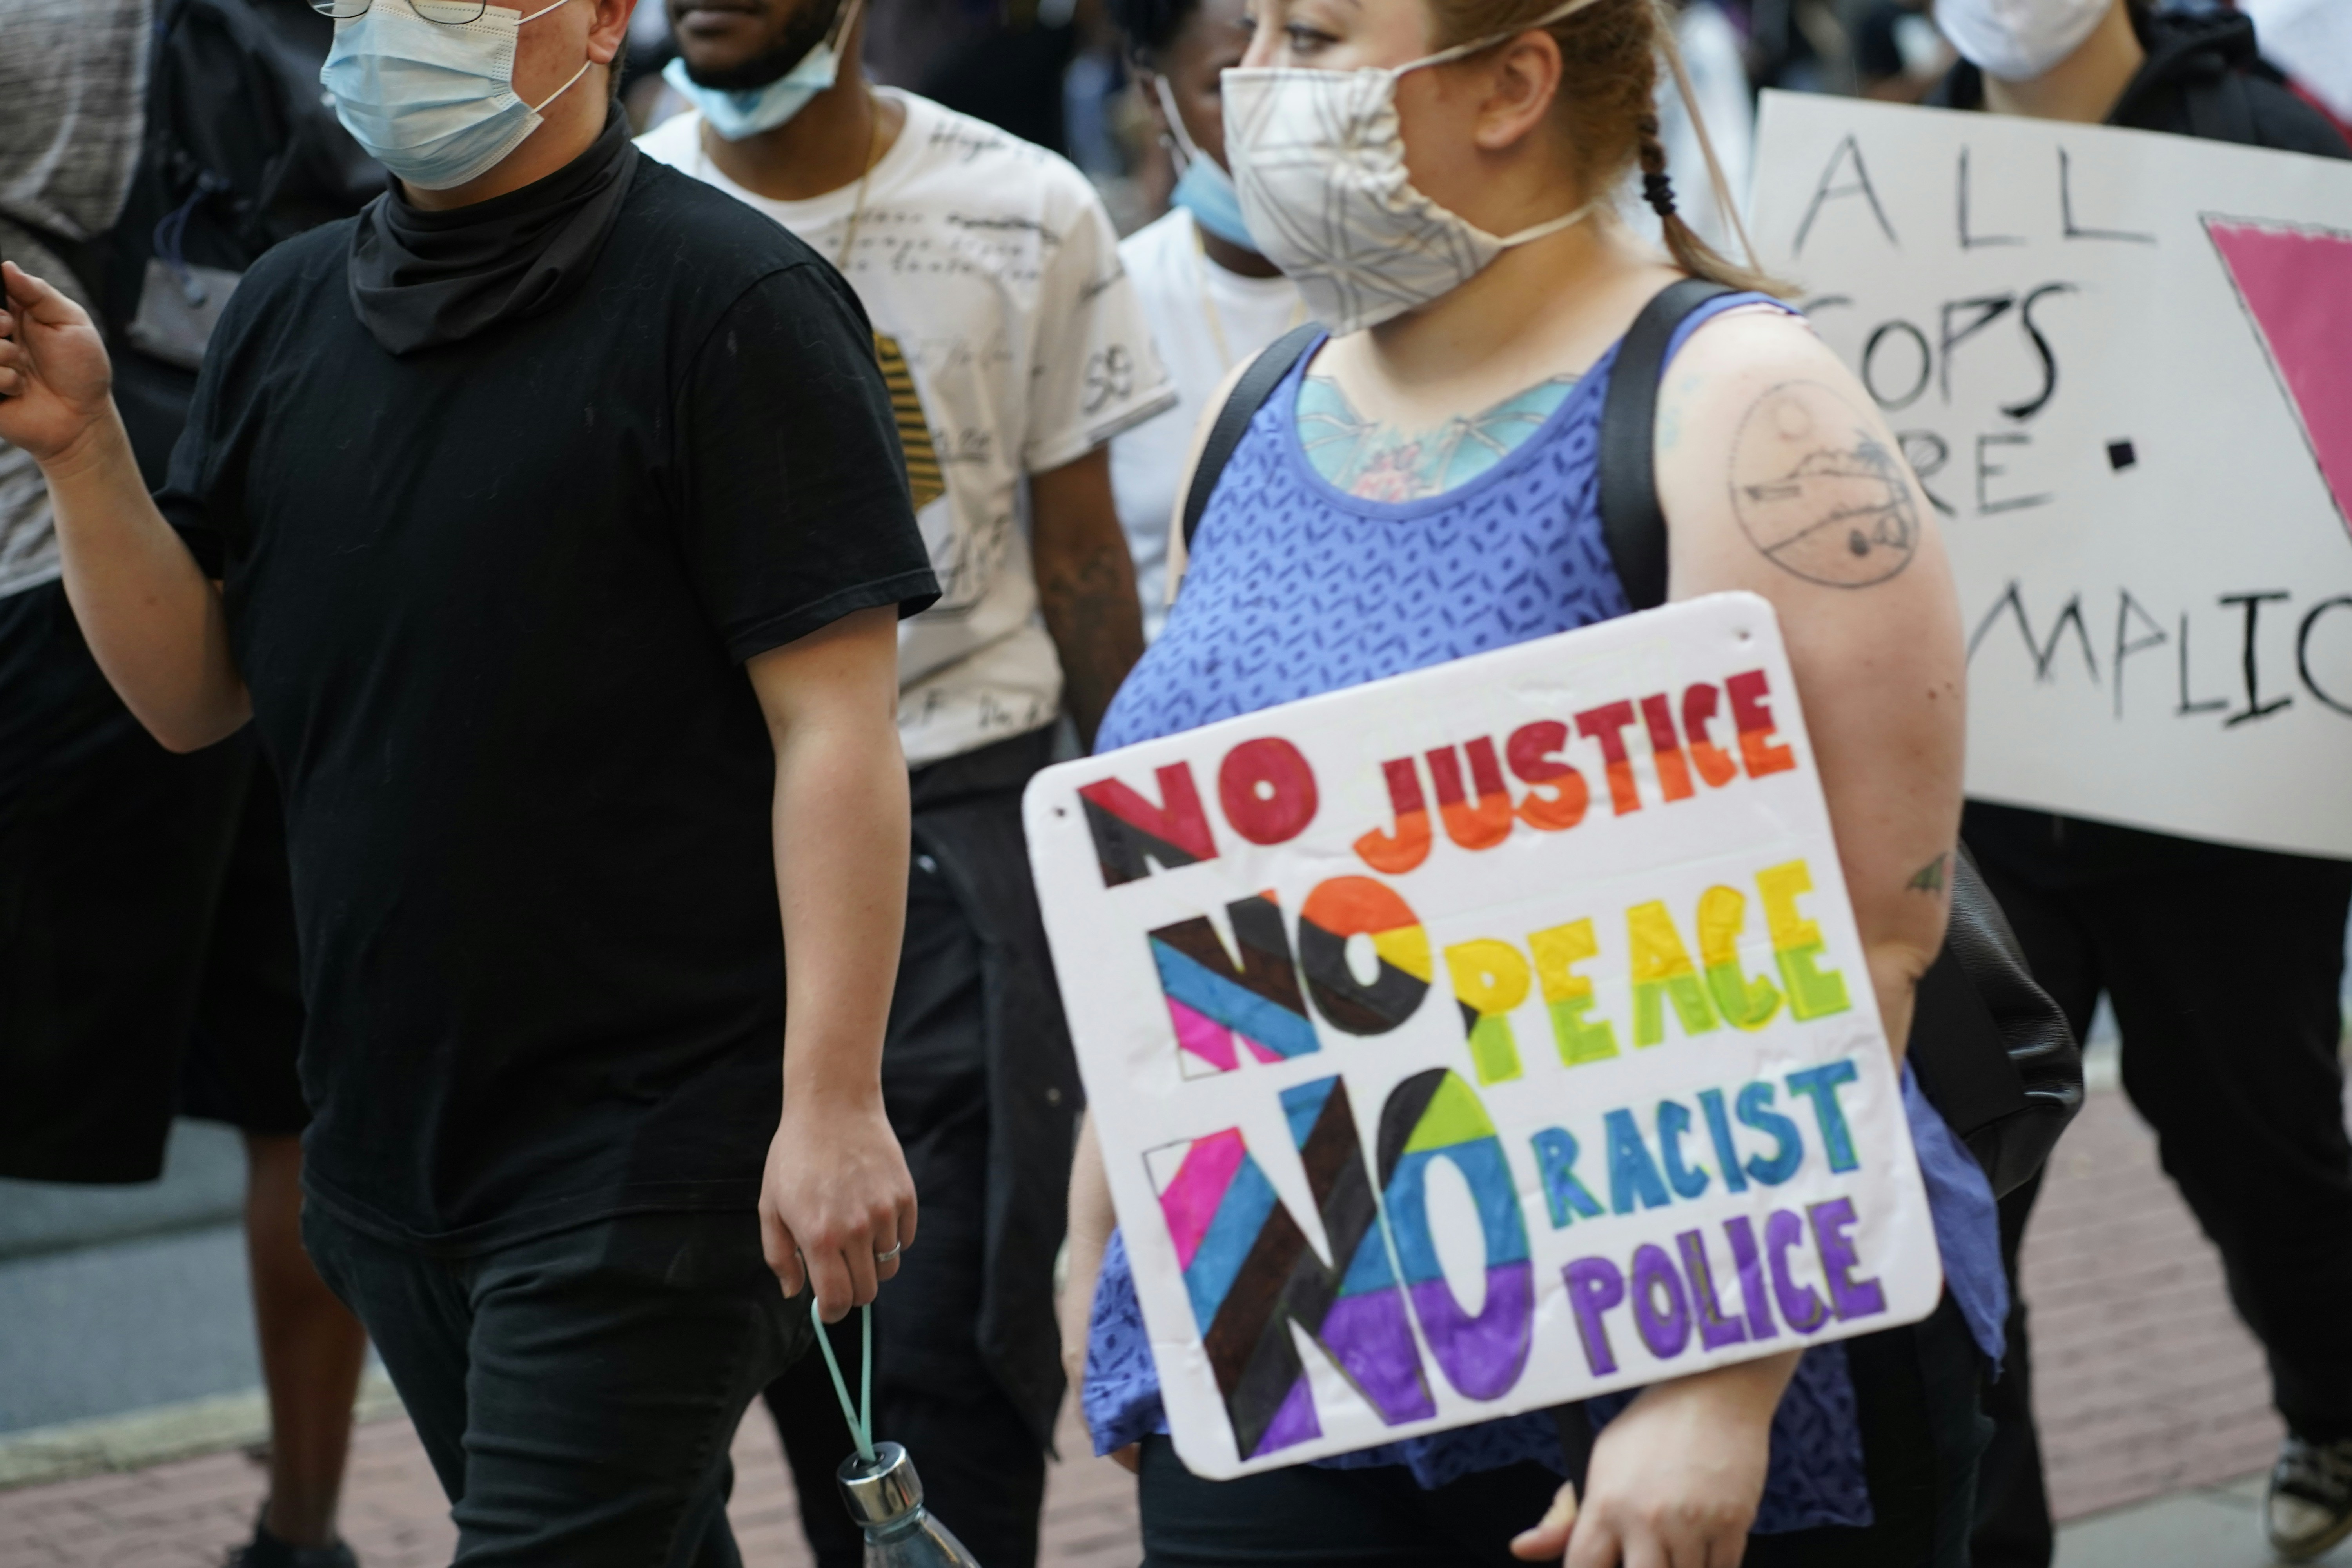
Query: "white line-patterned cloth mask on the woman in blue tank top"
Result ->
[[1223, 0, 1606, 336]]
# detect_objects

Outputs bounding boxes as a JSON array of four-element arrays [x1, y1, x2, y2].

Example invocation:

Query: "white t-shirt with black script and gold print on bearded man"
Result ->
[[637, 87, 1176, 766]]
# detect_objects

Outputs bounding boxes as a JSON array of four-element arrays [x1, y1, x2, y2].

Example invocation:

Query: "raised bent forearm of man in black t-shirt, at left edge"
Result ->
[[42, 409, 252, 752]]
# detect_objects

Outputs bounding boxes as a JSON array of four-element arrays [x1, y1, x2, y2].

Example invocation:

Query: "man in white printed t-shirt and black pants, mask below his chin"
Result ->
[[640, 0, 1176, 1568]]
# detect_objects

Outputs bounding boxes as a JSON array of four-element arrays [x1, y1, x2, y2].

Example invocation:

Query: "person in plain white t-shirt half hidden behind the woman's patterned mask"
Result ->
[[1110, 0, 1308, 639]]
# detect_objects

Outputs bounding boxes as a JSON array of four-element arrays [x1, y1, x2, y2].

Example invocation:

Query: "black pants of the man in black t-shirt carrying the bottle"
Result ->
[[303, 1201, 811, 1568]]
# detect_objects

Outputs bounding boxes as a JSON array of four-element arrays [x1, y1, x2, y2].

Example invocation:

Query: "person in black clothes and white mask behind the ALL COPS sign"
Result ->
[[1926, 0, 2352, 1568]]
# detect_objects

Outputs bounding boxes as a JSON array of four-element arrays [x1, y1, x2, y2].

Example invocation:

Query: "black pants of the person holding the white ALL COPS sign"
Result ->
[[1964, 804, 2352, 1568]]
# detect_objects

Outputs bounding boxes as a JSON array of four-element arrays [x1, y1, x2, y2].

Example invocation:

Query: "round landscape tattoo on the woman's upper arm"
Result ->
[[1731, 381, 1919, 588]]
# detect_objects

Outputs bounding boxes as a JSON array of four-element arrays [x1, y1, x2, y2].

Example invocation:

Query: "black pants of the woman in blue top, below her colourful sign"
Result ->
[[1141, 1298, 1987, 1568]]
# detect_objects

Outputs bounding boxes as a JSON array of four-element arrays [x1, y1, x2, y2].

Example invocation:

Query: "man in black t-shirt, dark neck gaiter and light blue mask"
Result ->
[[0, 0, 936, 1566]]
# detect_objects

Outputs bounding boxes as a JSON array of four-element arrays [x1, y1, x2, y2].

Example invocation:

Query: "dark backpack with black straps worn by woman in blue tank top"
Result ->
[[1183, 278, 2082, 1196]]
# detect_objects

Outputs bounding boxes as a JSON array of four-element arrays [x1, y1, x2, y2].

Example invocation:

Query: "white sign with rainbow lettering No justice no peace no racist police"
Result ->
[[1025, 595, 1940, 1476]]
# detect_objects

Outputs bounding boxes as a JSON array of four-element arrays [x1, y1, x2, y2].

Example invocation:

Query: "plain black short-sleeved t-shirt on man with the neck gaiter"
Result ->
[[160, 160, 936, 1248]]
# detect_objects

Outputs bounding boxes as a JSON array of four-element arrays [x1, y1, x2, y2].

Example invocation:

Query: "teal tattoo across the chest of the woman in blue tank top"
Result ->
[[1298, 376, 1576, 501]]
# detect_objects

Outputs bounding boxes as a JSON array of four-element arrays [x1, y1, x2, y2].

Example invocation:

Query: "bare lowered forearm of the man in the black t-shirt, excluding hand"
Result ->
[[776, 710, 908, 1110]]
